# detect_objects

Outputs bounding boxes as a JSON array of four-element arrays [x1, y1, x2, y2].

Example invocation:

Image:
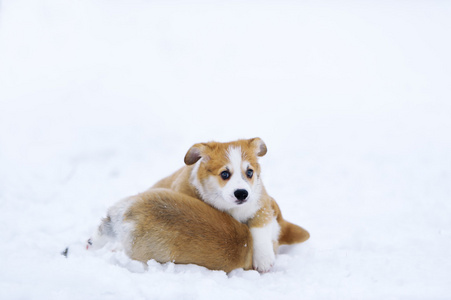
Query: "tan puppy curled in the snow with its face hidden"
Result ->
[[85, 189, 253, 272]]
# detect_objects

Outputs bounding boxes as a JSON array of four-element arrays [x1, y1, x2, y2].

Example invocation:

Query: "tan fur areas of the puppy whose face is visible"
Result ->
[[151, 138, 310, 251]]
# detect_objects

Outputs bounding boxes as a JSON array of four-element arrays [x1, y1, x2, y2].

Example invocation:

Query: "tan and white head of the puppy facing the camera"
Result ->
[[185, 138, 267, 211]]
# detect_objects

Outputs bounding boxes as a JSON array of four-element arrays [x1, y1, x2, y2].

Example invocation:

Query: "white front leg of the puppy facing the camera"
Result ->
[[250, 218, 280, 272]]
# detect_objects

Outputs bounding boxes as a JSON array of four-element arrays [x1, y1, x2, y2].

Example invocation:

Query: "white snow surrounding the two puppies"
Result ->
[[0, 0, 451, 300]]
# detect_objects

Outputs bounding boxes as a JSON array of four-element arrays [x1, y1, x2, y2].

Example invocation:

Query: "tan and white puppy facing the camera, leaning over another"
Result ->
[[149, 138, 309, 272]]
